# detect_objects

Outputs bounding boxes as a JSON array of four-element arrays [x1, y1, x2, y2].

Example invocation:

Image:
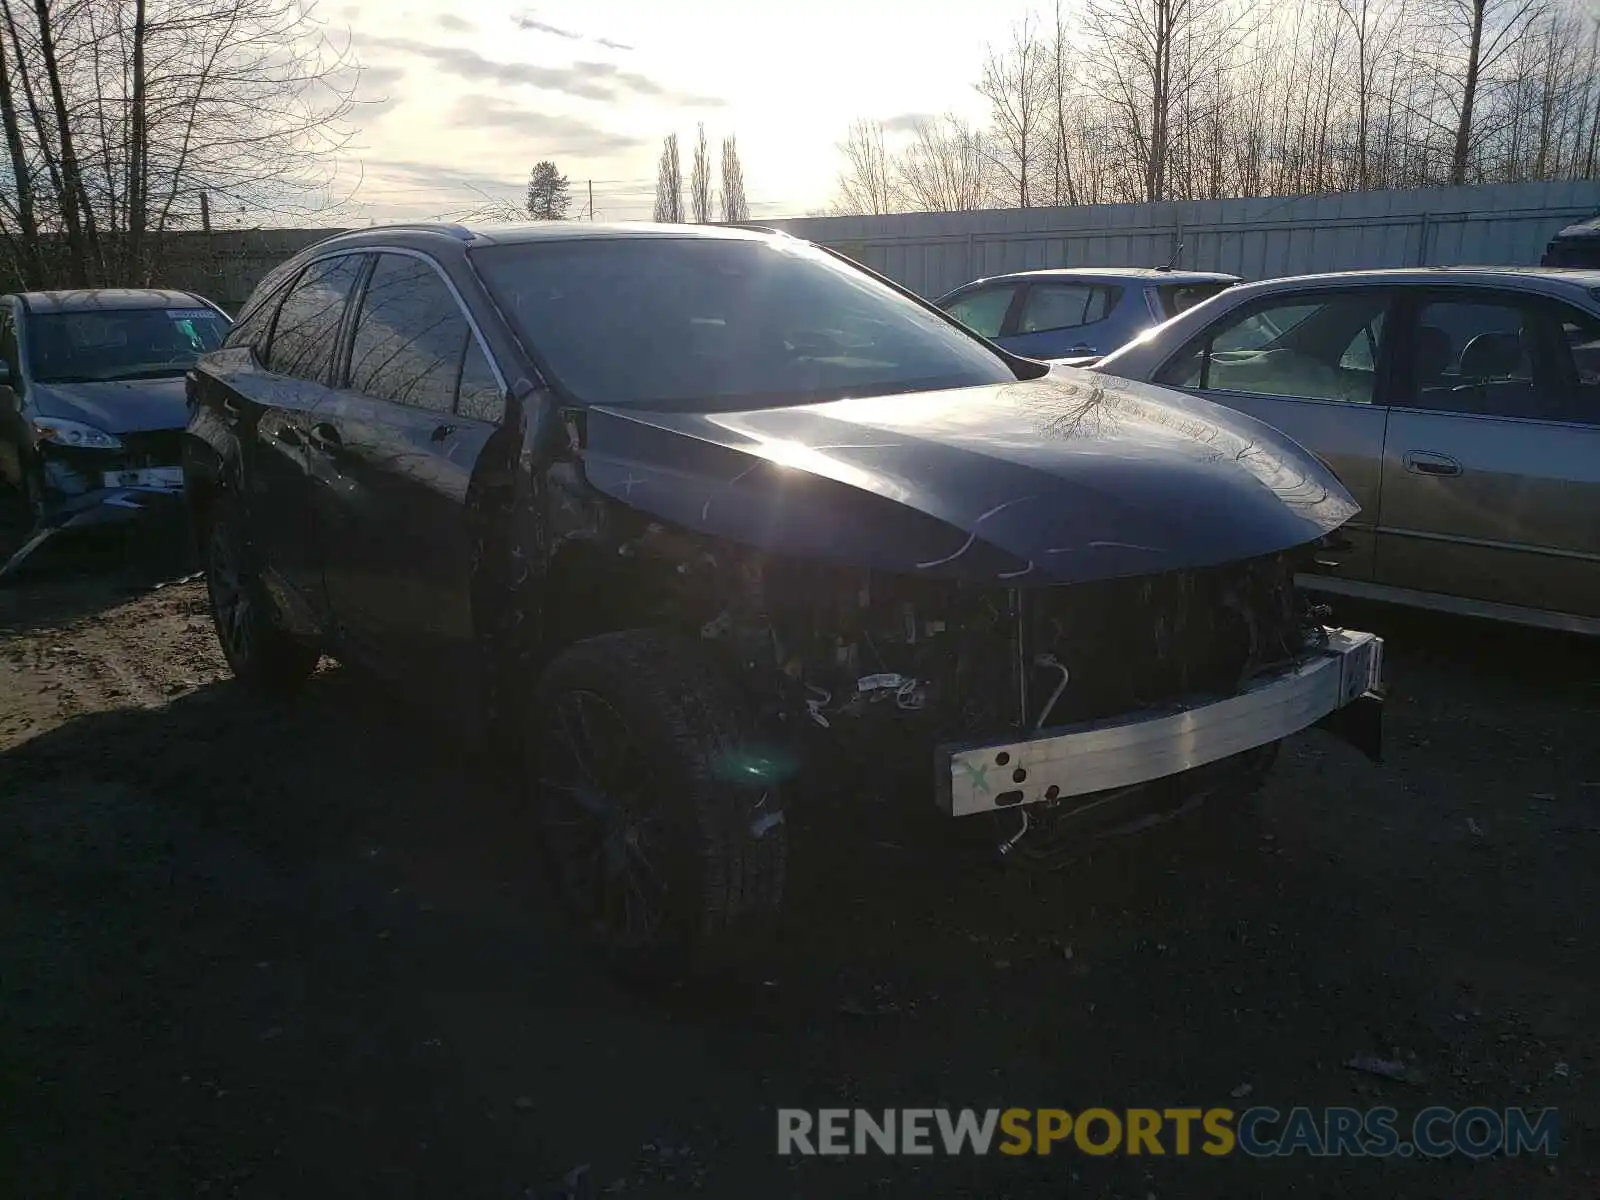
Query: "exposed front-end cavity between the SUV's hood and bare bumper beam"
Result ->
[[601, 523, 1325, 742]]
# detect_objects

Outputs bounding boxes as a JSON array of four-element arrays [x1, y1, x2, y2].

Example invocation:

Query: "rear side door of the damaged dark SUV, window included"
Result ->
[[195, 254, 365, 624]]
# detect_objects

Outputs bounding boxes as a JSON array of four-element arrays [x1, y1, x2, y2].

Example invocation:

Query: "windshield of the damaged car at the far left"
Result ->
[[27, 307, 227, 384]]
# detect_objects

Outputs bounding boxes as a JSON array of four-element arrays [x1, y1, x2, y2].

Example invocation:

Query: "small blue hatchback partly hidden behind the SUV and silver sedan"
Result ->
[[934, 267, 1238, 358]]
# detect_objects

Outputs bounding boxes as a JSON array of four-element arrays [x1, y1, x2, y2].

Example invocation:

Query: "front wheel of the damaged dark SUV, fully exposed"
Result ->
[[526, 630, 787, 982]]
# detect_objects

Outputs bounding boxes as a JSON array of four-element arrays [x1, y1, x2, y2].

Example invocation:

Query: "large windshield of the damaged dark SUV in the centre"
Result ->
[[472, 237, 1016, 411]]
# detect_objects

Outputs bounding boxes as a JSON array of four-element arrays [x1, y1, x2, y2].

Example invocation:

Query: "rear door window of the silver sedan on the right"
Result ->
[[1408, 298, 1581, 421]]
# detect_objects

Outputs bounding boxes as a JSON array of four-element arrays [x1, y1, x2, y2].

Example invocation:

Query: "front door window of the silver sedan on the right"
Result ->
[[1155, 293, 1389, 405]]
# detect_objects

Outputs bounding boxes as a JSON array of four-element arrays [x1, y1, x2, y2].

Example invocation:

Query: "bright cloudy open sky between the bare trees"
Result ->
[[318, 0, 1027, 224]]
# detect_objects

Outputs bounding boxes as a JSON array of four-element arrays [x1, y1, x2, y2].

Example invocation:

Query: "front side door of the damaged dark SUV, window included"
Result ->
[[312, 251, 504, 698]]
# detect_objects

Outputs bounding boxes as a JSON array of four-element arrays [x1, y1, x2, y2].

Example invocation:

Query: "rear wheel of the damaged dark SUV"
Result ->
[[205, 498, 322, 699]]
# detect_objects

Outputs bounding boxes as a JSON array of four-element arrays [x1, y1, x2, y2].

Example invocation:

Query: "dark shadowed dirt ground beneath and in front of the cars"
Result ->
[[0, 512, 1600, 1200]]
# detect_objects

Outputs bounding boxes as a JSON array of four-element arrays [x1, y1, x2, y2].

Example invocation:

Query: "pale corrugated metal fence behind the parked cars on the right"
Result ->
[[774, 179, 1600, 298]]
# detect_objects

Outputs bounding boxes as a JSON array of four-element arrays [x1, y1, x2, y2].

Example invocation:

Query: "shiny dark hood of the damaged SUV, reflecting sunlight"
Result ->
[[584, 366, 1358, 584]]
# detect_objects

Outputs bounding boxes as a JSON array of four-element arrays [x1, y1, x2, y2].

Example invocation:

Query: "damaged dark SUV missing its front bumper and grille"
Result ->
[[184, 222, 1381, 963]]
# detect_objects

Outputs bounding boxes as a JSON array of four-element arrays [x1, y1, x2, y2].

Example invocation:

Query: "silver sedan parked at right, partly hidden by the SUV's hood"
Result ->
[[1093, 267, 1600, 635]]
